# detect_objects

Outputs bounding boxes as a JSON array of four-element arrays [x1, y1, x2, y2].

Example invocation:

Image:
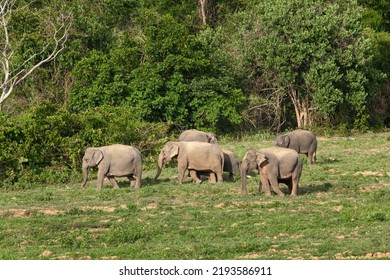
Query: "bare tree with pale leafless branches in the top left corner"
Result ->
[[0, 0, 71, 109]]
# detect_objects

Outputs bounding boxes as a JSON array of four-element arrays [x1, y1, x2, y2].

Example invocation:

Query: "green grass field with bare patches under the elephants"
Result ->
[[0, 133, 390, 260]]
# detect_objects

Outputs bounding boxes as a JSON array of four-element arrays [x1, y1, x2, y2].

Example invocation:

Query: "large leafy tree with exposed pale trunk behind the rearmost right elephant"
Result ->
[[225, 0, 378, 127]]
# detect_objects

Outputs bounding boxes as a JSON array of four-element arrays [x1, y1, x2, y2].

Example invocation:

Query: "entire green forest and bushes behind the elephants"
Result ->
[[0, 0, 390, 189]]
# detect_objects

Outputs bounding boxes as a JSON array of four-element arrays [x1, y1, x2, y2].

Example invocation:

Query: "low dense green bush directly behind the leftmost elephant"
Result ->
[[0, 104, 169, 187]]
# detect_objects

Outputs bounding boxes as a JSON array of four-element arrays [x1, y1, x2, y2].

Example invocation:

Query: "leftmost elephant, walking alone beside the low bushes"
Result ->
[[81, 144, 142, 190]]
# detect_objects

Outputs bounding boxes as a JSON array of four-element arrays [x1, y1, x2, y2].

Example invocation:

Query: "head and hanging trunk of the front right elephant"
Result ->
[[241, 149, 268, 195]]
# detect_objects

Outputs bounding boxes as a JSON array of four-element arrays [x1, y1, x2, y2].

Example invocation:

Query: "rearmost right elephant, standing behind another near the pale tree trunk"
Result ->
[[275, 129, 317, 164]]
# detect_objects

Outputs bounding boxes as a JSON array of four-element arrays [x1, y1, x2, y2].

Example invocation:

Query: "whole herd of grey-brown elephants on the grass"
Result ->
[[81, 129, 317, 196]]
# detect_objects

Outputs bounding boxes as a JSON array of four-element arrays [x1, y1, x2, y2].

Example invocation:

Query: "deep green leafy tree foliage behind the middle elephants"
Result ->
[[129, 14, 243, 129]]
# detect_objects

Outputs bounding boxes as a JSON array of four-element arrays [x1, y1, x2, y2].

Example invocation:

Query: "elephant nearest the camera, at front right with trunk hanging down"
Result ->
[[241, 147, 302, 196]]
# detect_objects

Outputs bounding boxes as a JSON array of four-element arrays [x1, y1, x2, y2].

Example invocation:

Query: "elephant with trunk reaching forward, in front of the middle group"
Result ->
[[155, 141, 224, 184]]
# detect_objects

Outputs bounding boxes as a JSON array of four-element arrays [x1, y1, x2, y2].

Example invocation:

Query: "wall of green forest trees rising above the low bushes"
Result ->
[[0, 0, 390, 132]]
